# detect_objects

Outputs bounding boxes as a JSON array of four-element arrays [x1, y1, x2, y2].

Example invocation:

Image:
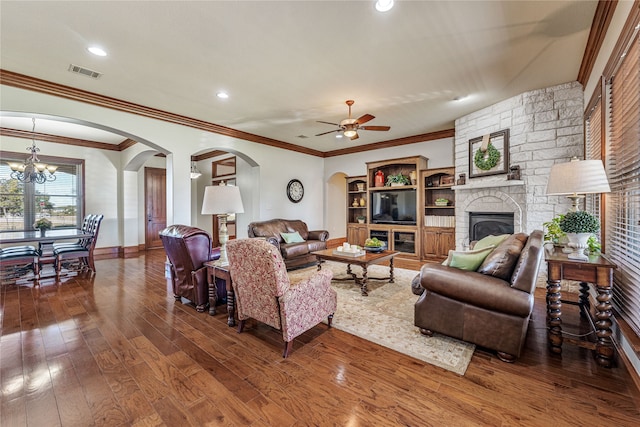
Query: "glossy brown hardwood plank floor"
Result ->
[[0, 250, 640, 426]]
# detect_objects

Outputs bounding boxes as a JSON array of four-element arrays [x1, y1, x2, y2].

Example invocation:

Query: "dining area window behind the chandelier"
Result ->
[[0, 152, 84, 230]]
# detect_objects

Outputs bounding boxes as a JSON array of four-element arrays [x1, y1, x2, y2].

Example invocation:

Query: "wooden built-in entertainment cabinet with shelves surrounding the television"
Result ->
[[346, 156, 455, 261]]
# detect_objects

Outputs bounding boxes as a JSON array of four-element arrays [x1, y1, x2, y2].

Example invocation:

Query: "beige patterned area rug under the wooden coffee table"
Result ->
[[289, 262, 475, 375]]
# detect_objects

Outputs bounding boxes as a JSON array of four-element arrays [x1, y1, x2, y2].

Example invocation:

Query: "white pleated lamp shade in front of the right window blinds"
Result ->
[[547, 158, 611, 195]]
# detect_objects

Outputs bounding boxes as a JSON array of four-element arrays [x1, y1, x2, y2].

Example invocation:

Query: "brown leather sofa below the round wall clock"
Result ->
[[248, 218, 329, 270]]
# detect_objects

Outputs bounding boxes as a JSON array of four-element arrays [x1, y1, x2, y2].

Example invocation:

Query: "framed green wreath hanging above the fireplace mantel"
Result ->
[[469, 129, 509, 178]]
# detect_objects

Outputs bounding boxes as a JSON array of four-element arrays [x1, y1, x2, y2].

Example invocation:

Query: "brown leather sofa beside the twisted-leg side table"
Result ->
[[413, 230, 544, 362]]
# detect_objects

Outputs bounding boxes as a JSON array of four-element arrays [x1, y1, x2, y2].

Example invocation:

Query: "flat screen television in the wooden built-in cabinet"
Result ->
[[371, 188, 417, 225]]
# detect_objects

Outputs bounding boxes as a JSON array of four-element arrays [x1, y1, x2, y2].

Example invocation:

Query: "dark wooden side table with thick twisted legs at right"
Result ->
[[545, 250, 616, 367]]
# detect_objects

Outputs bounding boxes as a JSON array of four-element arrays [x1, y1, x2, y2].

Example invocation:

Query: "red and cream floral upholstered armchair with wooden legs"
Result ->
[[227, 239, 337, 357]]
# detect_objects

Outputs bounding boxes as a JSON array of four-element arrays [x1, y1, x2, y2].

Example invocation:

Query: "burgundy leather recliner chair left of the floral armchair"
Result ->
[[160, 225, 220, 313]]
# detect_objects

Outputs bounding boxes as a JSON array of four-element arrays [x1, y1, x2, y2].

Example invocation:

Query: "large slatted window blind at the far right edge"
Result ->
[[606, 27, 640, 336]]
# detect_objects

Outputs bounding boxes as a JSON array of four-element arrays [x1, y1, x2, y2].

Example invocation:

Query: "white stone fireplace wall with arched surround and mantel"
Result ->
[[454, 82, 584, 248]]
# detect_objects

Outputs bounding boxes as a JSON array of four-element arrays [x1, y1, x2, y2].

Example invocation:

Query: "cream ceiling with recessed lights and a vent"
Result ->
[[0, 0, 597, 151]]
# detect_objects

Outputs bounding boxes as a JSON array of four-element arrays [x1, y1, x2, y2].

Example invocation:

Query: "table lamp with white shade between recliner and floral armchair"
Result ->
[[202, 181, 244, 266]]
